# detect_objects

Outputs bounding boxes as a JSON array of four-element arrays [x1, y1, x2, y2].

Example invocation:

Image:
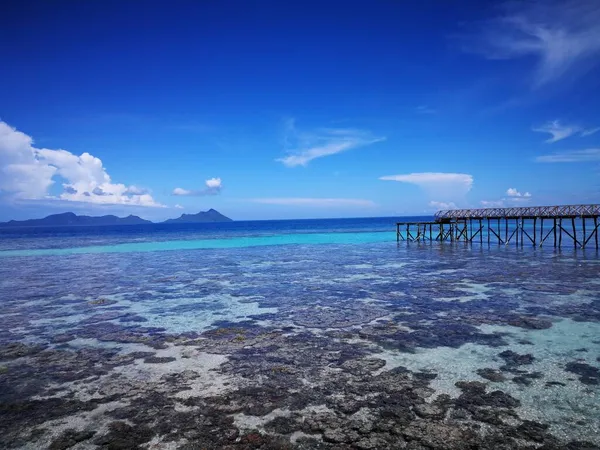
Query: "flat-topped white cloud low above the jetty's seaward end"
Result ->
[[379, 172, 473, 202]]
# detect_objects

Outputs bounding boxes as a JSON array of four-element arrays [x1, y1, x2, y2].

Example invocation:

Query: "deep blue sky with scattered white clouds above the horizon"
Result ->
[[0, 0, 600, 220]]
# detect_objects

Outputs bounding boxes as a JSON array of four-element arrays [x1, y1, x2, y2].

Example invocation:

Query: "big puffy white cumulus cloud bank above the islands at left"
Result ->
[[0, 121, 162, 206]]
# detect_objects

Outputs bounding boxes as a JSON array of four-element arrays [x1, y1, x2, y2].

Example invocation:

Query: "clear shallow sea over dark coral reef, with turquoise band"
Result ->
[[0, 217, 600, 450]]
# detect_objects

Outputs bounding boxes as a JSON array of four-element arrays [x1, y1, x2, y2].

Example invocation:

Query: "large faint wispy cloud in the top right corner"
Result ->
[[464, 0, 600, 86]]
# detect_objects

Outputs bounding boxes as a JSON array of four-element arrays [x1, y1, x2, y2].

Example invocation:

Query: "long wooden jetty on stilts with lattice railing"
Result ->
[[396, 205, 600, 249]]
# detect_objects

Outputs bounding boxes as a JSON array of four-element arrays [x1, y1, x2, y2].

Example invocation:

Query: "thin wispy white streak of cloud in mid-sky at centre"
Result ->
[[276, 120, 385, 167]]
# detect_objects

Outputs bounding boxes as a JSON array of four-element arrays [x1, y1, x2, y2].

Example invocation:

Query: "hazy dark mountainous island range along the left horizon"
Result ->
[[0, 208, 232, 228]]
